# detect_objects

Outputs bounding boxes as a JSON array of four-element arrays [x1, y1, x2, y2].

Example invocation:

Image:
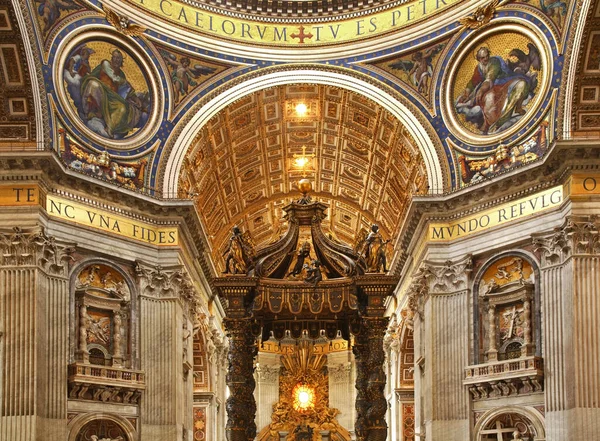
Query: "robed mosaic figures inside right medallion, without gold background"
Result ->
[[455, 43, 541, 135]]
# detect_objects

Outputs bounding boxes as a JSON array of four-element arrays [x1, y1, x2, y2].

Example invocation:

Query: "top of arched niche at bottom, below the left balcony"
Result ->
[[68, 413, 137, 441]]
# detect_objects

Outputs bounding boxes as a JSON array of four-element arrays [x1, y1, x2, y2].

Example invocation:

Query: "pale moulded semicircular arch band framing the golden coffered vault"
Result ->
[[162, 68, 449, 197]]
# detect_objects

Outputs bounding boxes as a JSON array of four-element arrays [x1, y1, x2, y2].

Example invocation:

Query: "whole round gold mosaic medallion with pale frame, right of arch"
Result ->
[[444, 24, 552, 144]]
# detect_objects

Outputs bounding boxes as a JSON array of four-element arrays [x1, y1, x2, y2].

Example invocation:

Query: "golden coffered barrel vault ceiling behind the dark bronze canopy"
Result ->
[[179, 84, 427, 264]]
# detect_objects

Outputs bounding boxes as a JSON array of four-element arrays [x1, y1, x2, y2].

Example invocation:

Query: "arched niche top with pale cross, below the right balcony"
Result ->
[[473, 406, 546, 441]]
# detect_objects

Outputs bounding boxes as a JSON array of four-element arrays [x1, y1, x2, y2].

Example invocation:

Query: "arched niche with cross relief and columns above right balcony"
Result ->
[[473, 251, 542, 364]]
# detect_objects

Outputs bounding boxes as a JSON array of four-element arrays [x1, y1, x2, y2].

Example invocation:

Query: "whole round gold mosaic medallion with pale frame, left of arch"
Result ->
[[55, 32, 161, 149]]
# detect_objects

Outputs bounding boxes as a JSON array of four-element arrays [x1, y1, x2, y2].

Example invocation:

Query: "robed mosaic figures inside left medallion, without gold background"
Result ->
[[63, 43, 152, 139]]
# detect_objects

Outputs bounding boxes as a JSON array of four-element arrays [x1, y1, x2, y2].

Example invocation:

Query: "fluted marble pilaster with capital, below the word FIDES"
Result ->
[[136, 263, 196, 441]]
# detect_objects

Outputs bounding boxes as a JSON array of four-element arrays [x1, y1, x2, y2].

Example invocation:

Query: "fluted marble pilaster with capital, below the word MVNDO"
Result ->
[[409, 256, 471, 441]]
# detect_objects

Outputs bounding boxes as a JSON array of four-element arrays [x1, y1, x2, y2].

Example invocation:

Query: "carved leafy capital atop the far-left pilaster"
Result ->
[[0, 227, 75, 277]]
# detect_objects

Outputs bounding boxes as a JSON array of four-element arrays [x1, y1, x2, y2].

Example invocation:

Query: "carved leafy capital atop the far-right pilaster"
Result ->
[[533, 215, 600, 268]]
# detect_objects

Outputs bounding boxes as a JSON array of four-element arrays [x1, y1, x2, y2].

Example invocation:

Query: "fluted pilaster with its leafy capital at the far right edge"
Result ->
[[533, 216, 600, 441]]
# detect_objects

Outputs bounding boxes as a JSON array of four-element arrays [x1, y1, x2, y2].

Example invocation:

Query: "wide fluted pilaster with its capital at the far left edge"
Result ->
[[0, 228, 74, 441]]
